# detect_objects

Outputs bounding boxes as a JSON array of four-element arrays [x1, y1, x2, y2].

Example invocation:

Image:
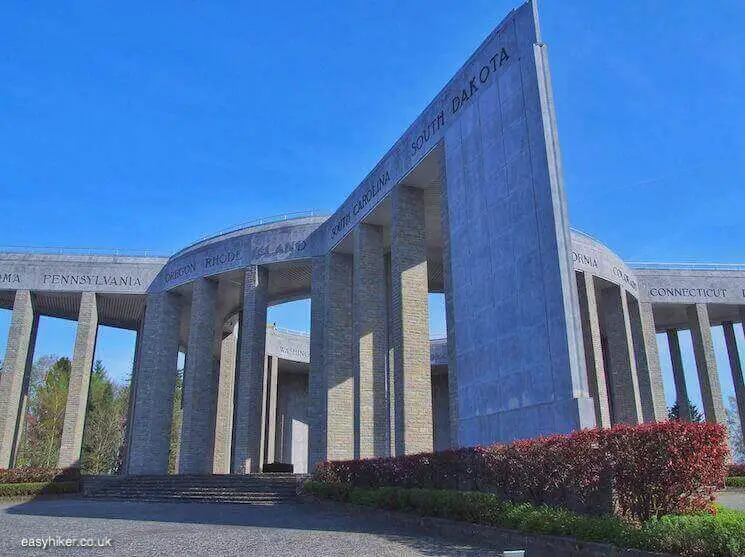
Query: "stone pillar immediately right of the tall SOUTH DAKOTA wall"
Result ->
[[577, 272, 613, 427]]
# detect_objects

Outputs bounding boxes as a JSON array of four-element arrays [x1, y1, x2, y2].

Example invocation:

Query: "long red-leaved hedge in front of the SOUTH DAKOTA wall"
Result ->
[[313, 421, 728, 521]]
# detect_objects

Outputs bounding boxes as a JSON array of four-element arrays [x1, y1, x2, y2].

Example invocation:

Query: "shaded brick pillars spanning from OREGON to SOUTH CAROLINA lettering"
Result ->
[[127, 182, 433, 474]]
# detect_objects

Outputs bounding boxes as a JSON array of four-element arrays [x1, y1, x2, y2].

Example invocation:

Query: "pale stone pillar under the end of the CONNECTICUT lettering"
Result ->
[[686, 304, 727, 424]]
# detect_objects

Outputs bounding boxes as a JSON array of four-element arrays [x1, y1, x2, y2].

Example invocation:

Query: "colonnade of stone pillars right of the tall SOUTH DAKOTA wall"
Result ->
[[576, 272, 745, 427]]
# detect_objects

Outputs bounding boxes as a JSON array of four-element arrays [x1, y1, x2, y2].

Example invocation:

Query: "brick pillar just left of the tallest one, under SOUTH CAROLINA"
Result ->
[[353, 223, 389, 458]]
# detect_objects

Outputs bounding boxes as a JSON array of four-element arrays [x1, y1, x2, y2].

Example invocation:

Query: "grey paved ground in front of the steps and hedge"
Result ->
[[0, 498, 501, 557]]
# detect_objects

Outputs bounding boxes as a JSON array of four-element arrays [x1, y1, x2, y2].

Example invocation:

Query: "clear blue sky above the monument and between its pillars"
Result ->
[[0, 0, 745, 416]]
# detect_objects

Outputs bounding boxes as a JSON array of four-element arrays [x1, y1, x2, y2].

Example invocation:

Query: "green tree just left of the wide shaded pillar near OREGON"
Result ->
[[81, 360, 129, 474]]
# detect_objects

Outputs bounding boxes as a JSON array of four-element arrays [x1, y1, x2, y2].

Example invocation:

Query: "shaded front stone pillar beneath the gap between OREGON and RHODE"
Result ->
[[179, 278, 217, 474]]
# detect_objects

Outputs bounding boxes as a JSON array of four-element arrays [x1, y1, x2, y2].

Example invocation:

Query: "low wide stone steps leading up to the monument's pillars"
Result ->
[[83, 474, 308, 505]]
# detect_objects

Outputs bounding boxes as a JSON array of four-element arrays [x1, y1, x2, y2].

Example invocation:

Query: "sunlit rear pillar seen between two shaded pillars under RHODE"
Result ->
[[212, 324, 238, 474]]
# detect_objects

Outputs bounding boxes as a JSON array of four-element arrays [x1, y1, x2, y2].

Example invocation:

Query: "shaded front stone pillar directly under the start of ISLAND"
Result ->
[[233, 266, 268, 474]]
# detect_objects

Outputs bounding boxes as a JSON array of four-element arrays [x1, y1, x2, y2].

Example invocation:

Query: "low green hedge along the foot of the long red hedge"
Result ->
[[305, 481, 745, 557]]
